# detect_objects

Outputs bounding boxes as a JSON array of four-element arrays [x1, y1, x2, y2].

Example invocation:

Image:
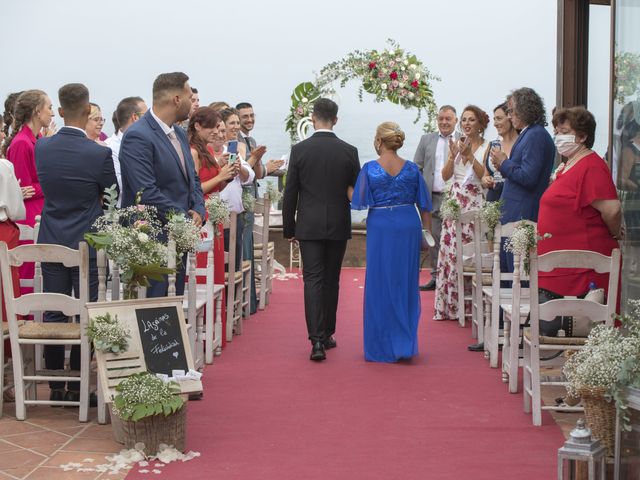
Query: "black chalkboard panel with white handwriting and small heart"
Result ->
[[136, 305, 189, 376]]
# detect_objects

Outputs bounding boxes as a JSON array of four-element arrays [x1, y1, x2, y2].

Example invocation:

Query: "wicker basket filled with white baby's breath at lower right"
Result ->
[[563, 300, 640, 455]]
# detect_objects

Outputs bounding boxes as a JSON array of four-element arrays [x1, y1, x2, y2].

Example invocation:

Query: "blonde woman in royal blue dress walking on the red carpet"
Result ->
[[351, 122, 431, 362]]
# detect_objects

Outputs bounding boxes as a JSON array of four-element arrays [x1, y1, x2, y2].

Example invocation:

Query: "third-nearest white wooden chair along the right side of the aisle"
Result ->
[[482, 222, 528, 368]]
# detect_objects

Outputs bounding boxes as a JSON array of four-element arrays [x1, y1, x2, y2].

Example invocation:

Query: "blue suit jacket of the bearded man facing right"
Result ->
[[120, 110, 205, 219]]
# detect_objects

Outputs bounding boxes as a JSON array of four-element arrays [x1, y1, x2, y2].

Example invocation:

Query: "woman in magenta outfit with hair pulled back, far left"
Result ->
[[2, 90, 54, 293]]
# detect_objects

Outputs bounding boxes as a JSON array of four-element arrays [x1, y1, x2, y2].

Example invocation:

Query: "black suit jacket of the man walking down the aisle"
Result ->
[[282, 132, 360, 240]]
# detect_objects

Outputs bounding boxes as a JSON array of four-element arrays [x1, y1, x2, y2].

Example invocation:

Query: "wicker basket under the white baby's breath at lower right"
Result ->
[[578, 388, 616, 457]]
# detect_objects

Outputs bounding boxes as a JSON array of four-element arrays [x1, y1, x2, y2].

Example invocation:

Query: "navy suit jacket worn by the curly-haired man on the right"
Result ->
[[500, 125, 556, 223]]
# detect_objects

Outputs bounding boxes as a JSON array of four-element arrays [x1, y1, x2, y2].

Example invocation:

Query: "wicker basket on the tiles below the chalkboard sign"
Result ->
[[122, 403, 187, 455]]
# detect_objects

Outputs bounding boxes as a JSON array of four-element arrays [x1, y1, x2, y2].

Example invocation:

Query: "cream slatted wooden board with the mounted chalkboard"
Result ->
[[87, 297, 202, 403]]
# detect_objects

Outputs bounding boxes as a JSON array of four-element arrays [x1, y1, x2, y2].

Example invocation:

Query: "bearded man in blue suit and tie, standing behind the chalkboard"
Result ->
[[120, 72, 205, 297]]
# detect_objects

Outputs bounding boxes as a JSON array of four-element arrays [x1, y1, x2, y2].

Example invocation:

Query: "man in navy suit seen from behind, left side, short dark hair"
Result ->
[[35, 83, 116, 403]]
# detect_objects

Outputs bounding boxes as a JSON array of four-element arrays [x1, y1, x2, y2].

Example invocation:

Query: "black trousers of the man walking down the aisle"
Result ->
[[299, 240, 347, 343]]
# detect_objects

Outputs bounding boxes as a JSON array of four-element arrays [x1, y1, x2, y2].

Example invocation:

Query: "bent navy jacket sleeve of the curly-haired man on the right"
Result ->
[[500, 132, 546, 190]]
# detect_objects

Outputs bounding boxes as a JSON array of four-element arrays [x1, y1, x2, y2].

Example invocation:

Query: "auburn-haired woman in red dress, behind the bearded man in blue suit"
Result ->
[[187, 107, 234, 347]]
